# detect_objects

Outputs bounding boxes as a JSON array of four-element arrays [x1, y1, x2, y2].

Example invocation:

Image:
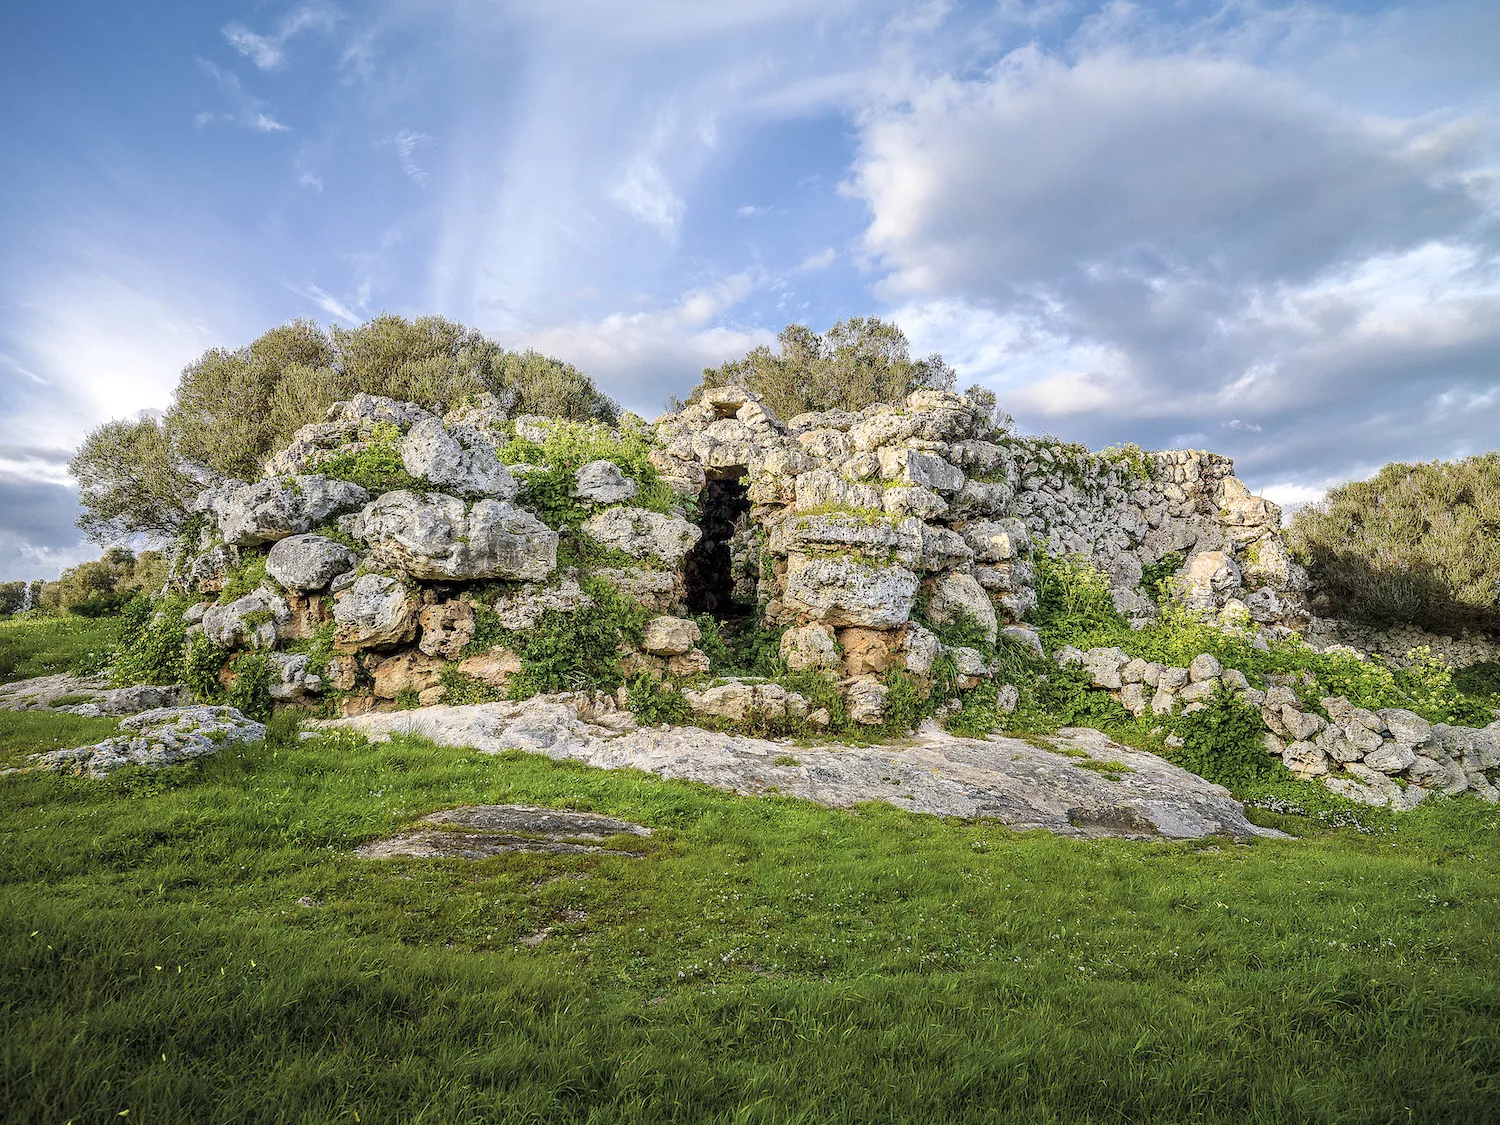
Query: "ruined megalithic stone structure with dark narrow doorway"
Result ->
[[173, 387, 1307, 726]]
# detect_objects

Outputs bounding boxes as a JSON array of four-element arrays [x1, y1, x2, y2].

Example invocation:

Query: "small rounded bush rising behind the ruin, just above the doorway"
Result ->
[[687, 317, 954, 419]]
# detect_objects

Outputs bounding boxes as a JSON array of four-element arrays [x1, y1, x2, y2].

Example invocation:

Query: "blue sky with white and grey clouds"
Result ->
[[0, 0, 1500, 581]]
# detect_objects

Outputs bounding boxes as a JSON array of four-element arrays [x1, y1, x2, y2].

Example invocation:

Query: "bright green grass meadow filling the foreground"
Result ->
[[0, 725, 1500, 1125]]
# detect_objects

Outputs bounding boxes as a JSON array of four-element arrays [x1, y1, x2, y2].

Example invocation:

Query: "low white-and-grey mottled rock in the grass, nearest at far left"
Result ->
[[14, 707, 266, 777]]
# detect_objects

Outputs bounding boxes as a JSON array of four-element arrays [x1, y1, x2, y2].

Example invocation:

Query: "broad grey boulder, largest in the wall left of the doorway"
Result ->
[[354, 491, 558, 582]]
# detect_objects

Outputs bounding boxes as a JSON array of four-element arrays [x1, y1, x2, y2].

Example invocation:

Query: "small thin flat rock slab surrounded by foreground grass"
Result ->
[[354, 804, 651, 860]]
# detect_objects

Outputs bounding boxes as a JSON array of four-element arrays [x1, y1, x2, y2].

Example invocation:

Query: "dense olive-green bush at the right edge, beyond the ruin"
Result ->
[[1287, 453, 1500, 630]]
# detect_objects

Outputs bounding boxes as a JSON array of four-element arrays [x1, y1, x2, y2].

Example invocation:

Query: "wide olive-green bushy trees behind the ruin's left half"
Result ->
[[71, 314, 620, 542]]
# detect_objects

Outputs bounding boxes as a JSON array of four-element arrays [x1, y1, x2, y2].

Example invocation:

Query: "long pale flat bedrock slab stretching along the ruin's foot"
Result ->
[[308, 693, 1283, 840]]
